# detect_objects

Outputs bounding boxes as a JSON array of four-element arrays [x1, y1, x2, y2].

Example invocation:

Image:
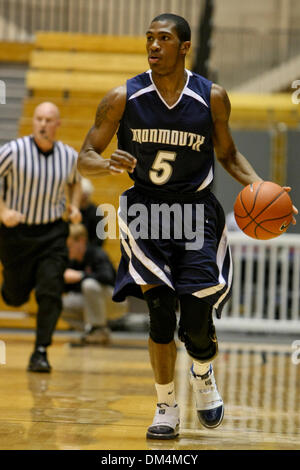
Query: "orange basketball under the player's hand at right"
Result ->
[[234, 181, 293, 240]]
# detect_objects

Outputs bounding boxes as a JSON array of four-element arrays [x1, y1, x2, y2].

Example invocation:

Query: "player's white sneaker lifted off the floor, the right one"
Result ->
[[190, 365, 224, 428]]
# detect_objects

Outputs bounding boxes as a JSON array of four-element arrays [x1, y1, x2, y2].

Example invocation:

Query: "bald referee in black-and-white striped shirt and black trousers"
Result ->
[[0, 102, 81, 372]]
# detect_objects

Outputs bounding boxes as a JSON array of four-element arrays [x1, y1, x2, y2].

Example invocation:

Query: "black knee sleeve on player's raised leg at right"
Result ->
[[178, 294, 218, 362]]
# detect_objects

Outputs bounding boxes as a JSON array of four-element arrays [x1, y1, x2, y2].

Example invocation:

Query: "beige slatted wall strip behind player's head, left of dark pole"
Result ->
[[0, 0, 203, 41]]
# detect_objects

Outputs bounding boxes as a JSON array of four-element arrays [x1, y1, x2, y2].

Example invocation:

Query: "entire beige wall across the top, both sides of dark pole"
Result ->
[[0, 0, 300, 88]]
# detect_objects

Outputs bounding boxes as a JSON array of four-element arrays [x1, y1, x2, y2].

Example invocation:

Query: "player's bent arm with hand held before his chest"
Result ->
[[77, 85, 136, 177]]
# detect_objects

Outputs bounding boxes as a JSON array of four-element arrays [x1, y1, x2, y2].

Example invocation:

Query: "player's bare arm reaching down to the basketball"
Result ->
[[211, 84, 262, 186]]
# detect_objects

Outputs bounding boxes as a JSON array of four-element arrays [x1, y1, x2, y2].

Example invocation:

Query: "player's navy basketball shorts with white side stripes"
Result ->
[[113, 187, 232, 318]]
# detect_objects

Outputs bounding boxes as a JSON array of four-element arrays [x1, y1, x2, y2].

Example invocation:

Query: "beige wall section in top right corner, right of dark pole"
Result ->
[[210, 0, 300, 89]]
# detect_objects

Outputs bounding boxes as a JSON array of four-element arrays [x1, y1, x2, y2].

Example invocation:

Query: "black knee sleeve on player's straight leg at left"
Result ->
[[144, 286, 176, 344]]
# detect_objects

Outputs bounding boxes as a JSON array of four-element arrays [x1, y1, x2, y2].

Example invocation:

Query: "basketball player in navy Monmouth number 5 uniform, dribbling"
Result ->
[[78, 14, 296, 439]]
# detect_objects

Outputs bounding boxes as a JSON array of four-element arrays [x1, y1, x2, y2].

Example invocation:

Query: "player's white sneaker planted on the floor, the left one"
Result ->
[[147, 403, 180, 439]]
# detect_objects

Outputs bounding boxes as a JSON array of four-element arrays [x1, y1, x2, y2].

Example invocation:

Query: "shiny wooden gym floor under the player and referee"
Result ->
[[0, 331, 300, 450]]
